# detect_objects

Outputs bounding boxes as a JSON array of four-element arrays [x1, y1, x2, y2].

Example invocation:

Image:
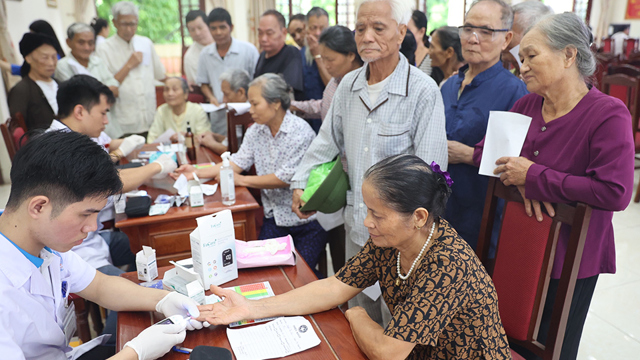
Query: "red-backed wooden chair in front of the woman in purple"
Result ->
[[476, 178, 591, 360]]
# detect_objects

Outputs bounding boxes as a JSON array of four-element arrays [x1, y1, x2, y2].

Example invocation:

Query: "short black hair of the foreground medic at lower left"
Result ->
[[6, 131, 122, 217]]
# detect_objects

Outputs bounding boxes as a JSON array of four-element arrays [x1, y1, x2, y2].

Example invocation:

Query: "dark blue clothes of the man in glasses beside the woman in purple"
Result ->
[[442, 61, 527, 249]]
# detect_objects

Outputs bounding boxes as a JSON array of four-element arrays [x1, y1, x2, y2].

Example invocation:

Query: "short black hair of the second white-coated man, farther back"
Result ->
[[56, 75, 116, 119]]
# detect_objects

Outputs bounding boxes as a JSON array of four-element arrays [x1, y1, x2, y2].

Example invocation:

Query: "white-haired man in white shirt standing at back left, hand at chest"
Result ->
[[96, 1, 166, 138]]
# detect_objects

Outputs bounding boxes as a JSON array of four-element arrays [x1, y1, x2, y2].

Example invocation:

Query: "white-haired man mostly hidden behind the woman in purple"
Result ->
[[502, 0, 553, 75]]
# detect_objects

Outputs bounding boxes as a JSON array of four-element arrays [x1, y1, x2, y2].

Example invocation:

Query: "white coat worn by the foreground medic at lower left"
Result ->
[[0, 234, 96, 360]]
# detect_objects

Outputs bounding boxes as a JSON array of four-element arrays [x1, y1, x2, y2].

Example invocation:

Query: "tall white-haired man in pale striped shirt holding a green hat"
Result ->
[[291, 0, 447, 326]]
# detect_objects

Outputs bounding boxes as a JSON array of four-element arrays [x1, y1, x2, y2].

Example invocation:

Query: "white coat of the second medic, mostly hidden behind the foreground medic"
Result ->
[[47, 120, 114, 269]]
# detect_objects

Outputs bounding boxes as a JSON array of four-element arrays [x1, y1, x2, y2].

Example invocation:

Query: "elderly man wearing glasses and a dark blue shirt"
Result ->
[[442, 0, 527, 249]]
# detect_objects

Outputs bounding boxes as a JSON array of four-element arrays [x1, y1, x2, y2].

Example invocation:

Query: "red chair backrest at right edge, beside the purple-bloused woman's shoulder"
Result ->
[[602, 73, 640, 139]]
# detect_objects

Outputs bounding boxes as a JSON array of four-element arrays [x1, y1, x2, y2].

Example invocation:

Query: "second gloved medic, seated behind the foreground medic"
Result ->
[[49, 75, 176, 345]]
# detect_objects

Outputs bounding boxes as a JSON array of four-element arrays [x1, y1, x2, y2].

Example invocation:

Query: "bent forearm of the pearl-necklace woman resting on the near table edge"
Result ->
[[344, 306, 416, 360]]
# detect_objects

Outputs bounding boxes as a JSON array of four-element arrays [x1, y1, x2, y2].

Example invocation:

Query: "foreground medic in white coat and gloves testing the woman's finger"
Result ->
[[0, 131, 203, 360]]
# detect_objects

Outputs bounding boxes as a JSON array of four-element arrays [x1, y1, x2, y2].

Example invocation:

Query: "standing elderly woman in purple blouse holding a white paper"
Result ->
[[474, 13, 634, 359]]
